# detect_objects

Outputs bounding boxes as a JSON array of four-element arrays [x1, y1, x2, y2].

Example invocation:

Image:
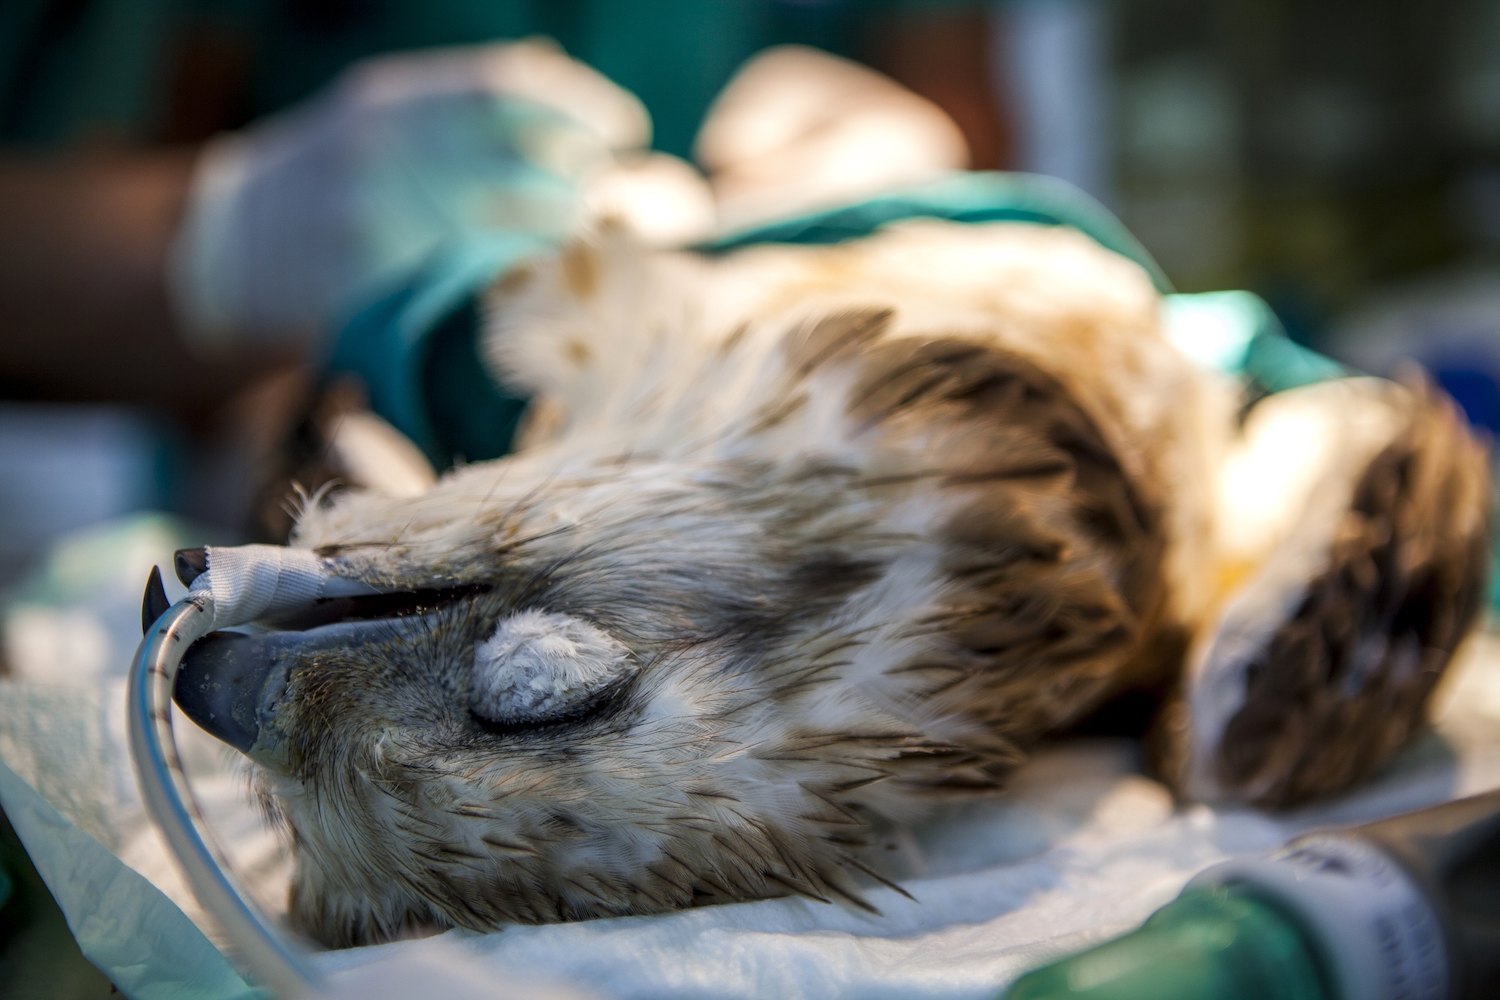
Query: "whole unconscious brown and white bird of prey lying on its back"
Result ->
[[149, 220, 1491, 946]]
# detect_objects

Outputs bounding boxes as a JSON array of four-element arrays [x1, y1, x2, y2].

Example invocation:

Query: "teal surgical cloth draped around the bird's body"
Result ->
[[329, 172, 1344, 469]]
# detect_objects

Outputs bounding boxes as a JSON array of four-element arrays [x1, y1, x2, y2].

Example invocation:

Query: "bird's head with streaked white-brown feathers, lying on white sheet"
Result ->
[[167, 457, 974, 945]]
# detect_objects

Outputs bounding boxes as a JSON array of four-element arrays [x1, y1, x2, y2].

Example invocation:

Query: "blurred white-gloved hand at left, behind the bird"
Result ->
[[171, 42, 651, 349]]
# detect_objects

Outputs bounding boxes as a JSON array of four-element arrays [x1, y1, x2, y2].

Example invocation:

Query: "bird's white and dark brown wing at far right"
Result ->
[[1166, 376, 1493, 807]]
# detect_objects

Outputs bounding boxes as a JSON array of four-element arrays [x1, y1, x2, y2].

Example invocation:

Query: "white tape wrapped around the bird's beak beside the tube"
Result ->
[[189, 546, 378, 628]]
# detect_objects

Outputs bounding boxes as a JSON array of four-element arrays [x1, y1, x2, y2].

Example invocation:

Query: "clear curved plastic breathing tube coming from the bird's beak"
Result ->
[[126, 591, 318, 997]]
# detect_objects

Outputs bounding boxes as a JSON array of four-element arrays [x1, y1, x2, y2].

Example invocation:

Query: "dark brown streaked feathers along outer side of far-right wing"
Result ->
[[1215, 374, 1493, 807]]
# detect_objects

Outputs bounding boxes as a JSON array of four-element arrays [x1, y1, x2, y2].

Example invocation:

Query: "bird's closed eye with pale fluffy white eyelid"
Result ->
[[470, 610, 635, 733]]
